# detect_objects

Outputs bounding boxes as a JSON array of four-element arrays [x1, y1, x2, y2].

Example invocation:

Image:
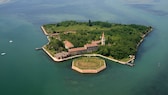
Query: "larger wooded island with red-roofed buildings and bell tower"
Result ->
[[41, 20, 152, 66]]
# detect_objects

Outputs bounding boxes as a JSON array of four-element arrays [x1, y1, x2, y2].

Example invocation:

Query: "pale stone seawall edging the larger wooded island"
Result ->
[[41, 26, 153, 66]]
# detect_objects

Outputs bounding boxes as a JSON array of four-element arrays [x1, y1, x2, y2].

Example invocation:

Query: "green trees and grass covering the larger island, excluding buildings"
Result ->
[[44, 20, 151, 59]]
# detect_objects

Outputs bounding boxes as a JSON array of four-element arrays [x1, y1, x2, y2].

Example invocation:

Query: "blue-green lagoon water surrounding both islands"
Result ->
[[0, 0, 168, 95]]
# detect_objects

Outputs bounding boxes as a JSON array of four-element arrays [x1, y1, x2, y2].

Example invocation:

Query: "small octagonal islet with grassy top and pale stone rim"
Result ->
[[72, 57, 106, 73]]
